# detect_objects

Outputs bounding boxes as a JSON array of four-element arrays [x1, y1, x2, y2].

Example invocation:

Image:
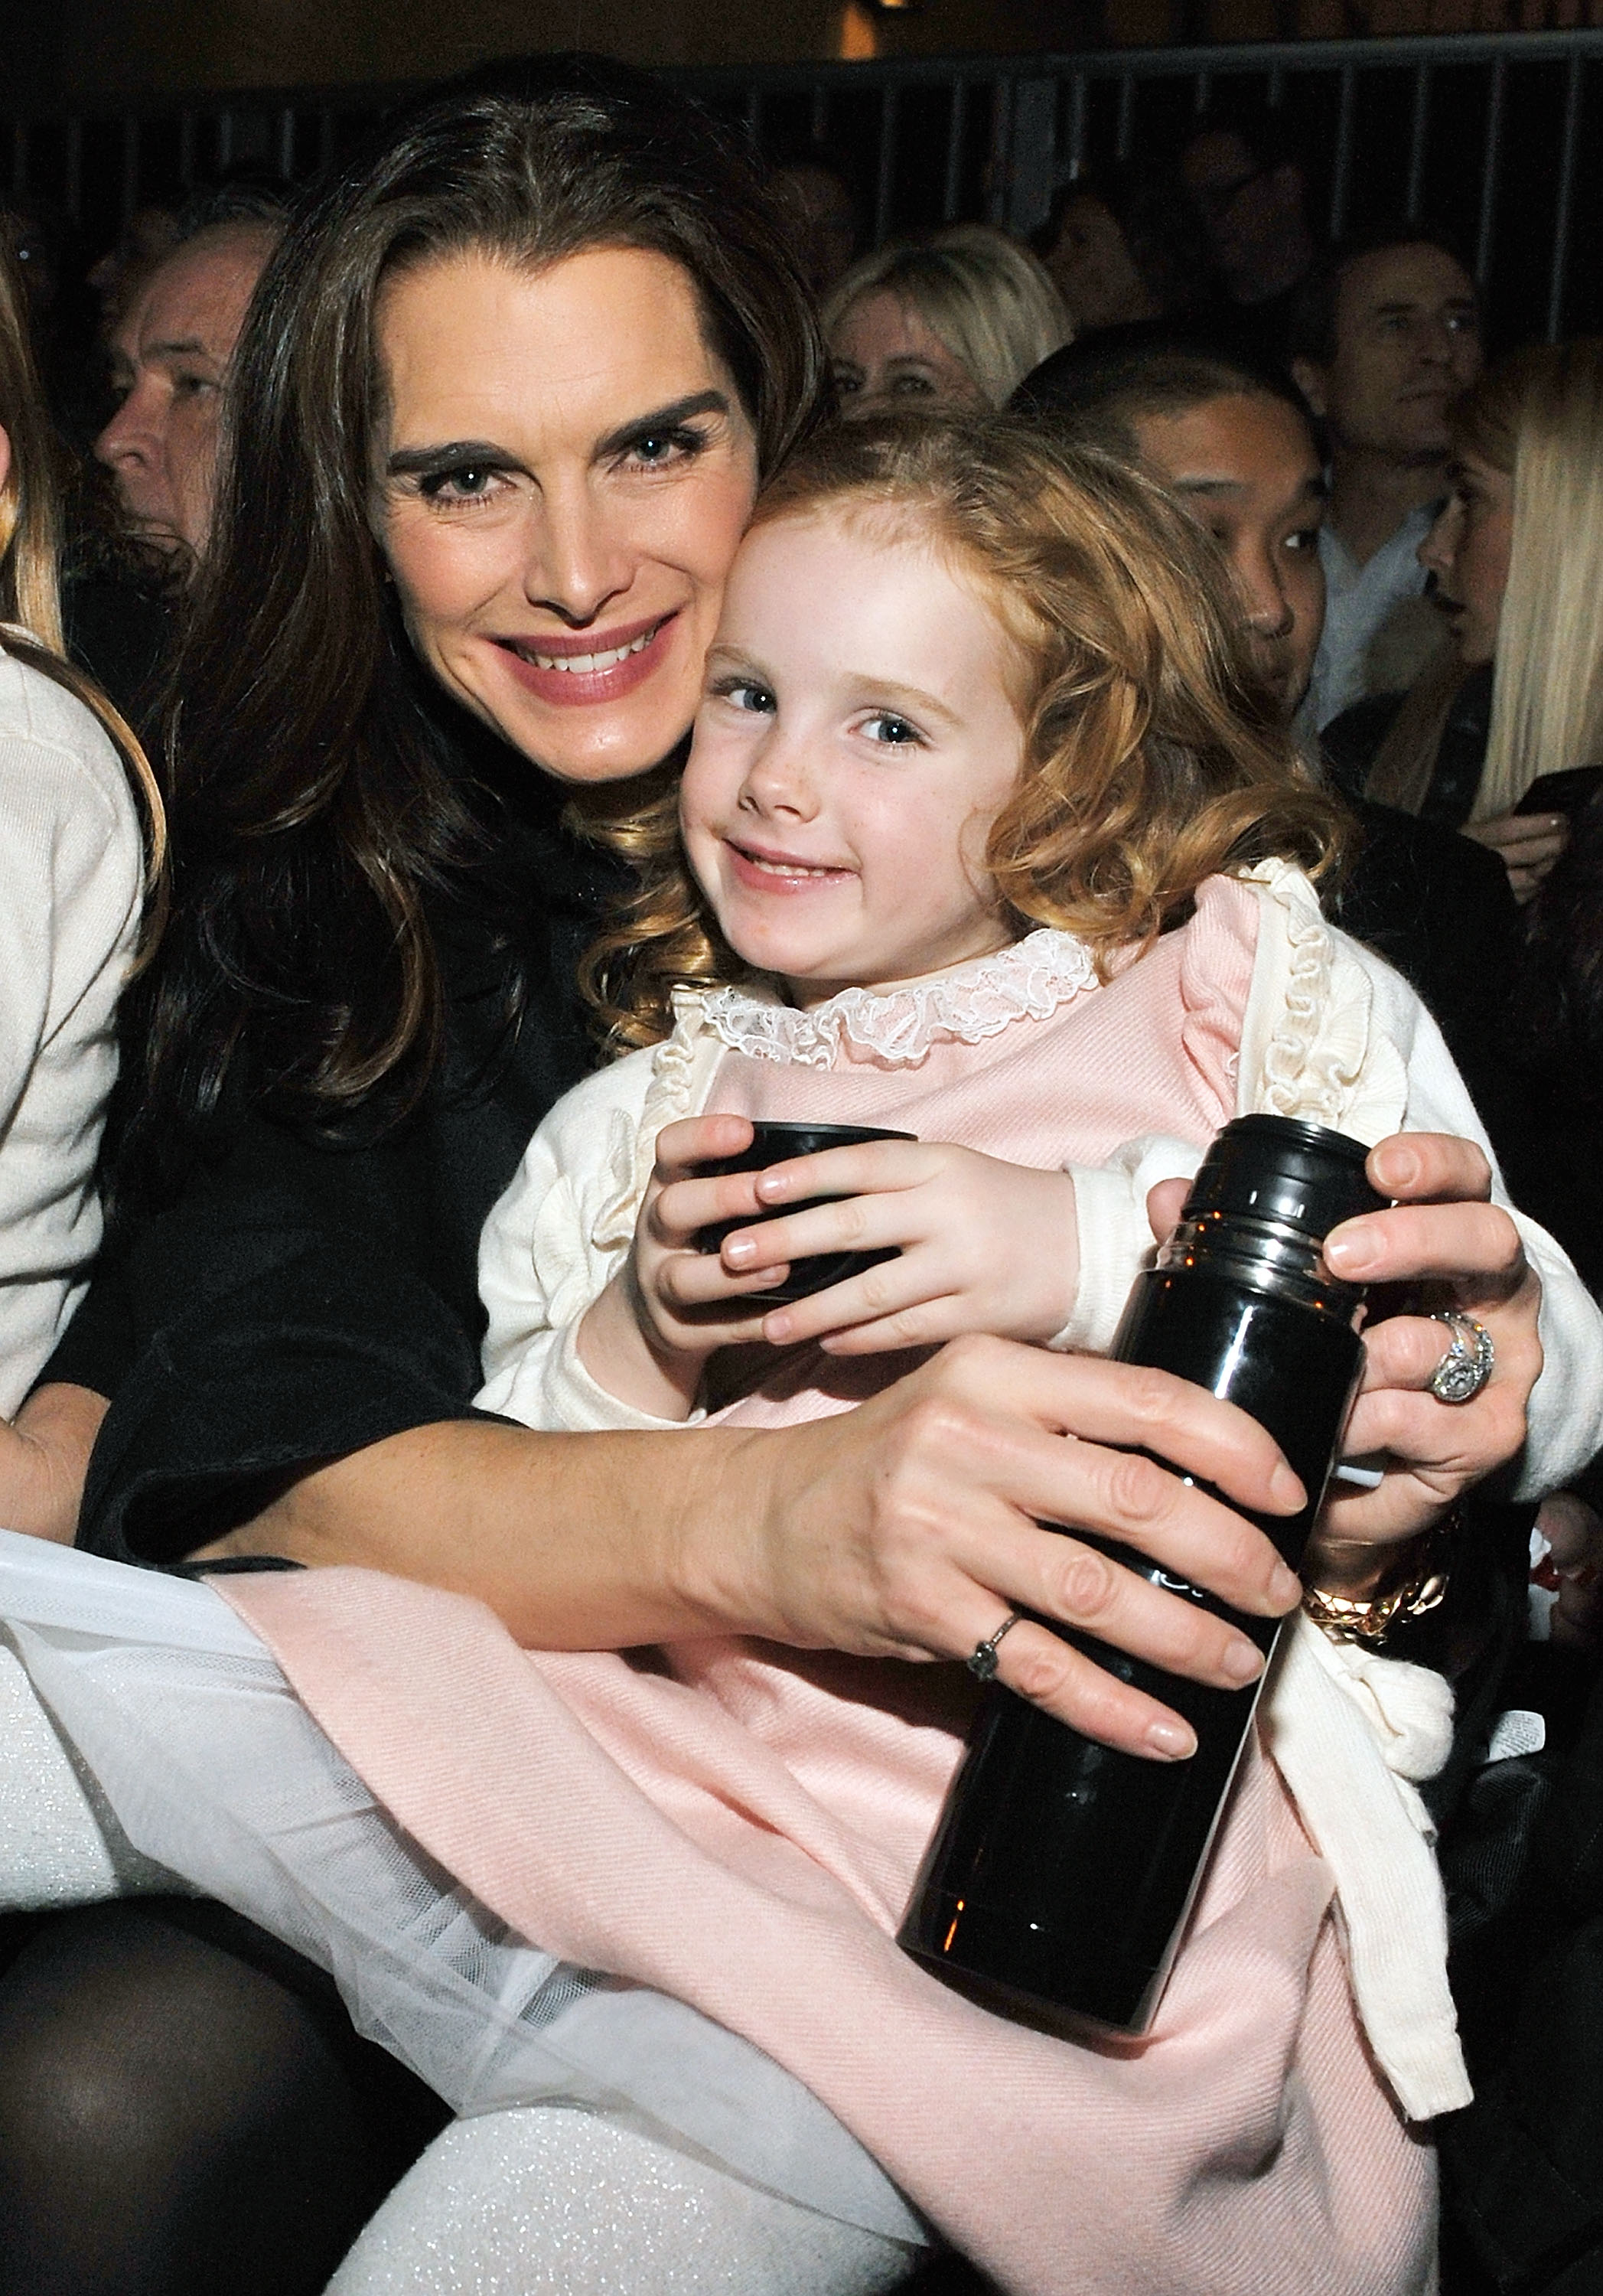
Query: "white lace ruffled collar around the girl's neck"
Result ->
[[702, 928, 1098, 1068]]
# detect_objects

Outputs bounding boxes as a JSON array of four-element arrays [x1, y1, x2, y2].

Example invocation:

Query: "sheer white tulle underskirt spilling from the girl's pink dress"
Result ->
[[0, 1531, 930, 2245]]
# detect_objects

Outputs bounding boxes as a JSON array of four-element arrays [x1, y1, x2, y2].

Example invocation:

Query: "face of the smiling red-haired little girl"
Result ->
[[679, 507, 1025, 1003]]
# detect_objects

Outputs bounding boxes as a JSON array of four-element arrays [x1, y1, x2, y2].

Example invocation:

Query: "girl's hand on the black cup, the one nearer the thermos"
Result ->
[[707, 1141, 1080, 1355]]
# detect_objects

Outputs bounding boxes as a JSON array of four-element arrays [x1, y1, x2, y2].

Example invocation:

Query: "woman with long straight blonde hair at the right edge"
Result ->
[[1328, 340, 1603, 900]]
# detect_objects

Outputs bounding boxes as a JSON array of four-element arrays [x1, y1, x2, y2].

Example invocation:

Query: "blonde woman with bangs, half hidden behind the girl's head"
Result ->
[[823, 223, 1075, 418]]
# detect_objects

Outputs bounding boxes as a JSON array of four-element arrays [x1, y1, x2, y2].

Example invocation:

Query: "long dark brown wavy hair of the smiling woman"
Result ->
[[131, 55, 823, 1162]]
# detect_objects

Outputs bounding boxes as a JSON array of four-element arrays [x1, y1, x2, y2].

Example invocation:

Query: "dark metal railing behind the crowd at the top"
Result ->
[[12, 30, 1603, 338]]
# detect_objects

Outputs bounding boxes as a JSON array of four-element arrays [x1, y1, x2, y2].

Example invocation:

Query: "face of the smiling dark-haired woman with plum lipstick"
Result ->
[[374, 248, 755, 781]]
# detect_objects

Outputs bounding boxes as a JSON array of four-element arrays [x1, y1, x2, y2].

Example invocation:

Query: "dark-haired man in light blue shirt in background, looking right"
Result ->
[[1286, 223, 1481, 728]]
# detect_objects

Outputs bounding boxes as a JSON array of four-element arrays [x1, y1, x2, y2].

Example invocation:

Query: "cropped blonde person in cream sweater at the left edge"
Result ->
[[0, 250, 163, 1525]]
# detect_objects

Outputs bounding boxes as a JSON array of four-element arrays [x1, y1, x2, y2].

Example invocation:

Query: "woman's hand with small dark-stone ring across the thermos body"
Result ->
[[702, 1339, 1302, 1761]]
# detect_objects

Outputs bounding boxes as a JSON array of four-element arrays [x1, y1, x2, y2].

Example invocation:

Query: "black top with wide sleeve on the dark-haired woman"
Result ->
[[53, 781, 613, 1564]]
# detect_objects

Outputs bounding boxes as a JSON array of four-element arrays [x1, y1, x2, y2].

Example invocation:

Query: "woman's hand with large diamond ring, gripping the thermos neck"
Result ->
[[1148, 1132, 1541, 1598]]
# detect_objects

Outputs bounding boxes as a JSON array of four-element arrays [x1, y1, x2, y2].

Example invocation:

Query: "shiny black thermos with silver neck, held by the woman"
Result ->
[[901, 1116, 1385, 2032]]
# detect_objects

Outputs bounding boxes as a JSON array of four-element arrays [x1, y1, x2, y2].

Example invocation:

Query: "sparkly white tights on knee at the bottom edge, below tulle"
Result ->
[[328, 2105, 919, 2296]]
